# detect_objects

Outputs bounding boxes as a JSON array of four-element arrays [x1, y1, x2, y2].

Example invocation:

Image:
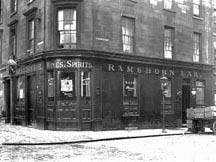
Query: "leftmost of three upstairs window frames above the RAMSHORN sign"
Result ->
[[121, 16, 135, 54]]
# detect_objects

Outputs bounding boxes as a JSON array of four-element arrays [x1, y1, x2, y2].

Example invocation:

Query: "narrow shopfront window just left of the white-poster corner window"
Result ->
[[47, 72, 55, 101]]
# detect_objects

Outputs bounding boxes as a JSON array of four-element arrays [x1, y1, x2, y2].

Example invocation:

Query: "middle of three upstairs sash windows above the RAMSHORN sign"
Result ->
[[164, 27, 174, 59]]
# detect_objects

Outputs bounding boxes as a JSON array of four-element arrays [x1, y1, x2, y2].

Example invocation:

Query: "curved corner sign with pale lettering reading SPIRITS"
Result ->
[[47, 59, 92, 69]]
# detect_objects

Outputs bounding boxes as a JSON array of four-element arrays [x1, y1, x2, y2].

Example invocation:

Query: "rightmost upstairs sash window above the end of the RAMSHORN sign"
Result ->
[[193, 33, 201, 62]]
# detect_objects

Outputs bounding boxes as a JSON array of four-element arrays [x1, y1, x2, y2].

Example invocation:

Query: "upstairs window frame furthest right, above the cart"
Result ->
[[192, 32, 202, 63]]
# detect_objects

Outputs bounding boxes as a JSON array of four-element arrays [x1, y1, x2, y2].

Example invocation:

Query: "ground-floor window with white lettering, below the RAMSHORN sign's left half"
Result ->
[[123, 75, 137, 98]]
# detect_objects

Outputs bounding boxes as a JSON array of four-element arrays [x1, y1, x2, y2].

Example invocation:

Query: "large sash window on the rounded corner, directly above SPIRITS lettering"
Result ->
[[58, 8, 77, 48]]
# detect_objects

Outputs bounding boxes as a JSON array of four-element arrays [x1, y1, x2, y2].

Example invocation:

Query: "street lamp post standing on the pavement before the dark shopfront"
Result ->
[[160, 76, 168, 133]]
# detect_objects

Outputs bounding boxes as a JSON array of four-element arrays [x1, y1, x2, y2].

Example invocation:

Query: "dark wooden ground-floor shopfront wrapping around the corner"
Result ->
[[5, 53, 213, 130]]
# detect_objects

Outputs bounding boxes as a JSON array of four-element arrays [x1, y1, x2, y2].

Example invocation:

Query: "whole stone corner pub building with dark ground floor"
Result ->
[[2, 0, 213, 130]]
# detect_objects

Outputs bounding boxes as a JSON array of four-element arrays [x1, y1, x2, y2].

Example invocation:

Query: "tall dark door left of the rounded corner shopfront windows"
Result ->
[[27, 75, 36, 125]]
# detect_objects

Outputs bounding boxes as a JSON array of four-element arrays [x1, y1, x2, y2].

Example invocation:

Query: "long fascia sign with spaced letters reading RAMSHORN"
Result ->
[[106, 64, 202, 78]]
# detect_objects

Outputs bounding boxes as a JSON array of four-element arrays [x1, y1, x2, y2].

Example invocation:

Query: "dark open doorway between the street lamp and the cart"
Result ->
[[182, 85, 190, 124]]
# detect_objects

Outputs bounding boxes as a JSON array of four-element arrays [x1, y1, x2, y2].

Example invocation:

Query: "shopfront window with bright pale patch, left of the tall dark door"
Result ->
[[17, 76, 25, 102]]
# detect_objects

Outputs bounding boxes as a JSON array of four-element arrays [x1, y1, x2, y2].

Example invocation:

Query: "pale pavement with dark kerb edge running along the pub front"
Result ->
[[0, 122, 195, 145]]
